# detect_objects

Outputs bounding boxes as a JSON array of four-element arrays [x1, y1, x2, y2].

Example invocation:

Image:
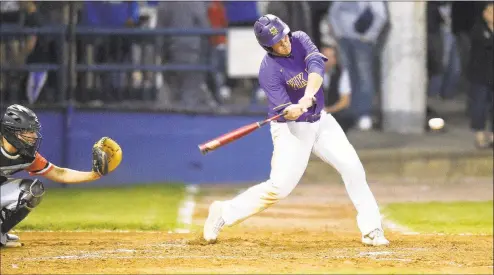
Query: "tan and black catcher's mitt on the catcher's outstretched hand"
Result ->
[[93, 137, 122, 176]]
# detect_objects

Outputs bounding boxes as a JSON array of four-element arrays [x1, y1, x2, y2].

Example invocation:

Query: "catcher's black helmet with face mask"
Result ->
[[0, 104, 41, 157]]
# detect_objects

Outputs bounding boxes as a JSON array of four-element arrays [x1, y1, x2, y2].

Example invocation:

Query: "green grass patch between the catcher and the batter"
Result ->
[[16, 184, 185, 231]]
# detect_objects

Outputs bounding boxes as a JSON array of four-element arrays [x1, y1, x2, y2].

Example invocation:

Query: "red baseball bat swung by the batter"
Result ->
[[198, 112, 285, 155]]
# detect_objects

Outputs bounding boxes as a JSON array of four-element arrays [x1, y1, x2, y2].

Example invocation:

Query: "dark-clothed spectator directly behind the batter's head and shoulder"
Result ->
[[266, 1, 314, 37]]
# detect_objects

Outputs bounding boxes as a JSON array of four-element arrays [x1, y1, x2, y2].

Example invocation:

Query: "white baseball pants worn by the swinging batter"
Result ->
[[223, 111, 382, 235]]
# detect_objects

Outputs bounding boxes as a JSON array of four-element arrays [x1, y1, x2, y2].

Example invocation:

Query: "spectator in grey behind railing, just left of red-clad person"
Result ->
[[157, 1, 218, 110]]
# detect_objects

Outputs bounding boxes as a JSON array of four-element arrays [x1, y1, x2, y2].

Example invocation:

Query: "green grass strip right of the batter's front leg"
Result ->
[[383, 201, 493, 234]]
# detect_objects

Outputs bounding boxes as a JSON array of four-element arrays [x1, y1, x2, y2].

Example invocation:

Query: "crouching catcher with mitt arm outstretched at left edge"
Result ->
[[0, 104, 122, 247]]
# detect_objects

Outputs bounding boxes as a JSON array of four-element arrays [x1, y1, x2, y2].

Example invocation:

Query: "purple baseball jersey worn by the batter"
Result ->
[[259, 31, 327, 122]]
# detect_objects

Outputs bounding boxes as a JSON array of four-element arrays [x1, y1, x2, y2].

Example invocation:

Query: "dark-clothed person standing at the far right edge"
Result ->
[[469, 2, 494, 149]]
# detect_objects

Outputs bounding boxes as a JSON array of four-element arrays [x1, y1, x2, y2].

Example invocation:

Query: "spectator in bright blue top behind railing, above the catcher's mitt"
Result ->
[[82, 1, 139, 101]]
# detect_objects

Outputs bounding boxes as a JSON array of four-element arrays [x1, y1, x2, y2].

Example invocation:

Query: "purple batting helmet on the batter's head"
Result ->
[[254, 14, 291, 52]]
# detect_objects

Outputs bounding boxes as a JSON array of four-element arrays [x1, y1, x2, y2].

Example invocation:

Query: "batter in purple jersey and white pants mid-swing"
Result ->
[[203, 14, 389, 246]]
